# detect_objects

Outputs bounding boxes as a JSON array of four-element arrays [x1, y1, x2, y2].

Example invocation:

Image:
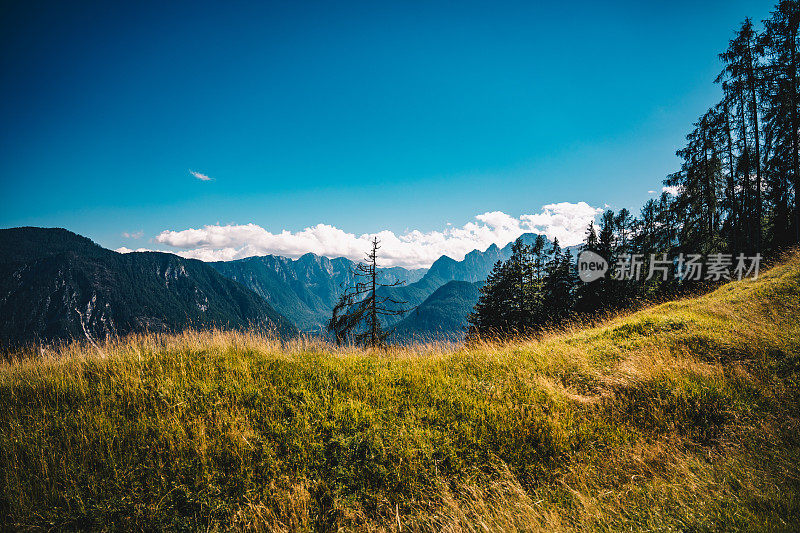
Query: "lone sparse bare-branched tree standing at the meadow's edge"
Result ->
[[328, 237, 407, 348]]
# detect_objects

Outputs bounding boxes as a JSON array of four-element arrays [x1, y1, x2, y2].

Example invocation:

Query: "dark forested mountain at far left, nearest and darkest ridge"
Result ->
[[0, 227, 297, 348]]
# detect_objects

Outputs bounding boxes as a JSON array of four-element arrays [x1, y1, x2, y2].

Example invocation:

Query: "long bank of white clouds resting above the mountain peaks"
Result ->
[[155, 202, 602, 268]]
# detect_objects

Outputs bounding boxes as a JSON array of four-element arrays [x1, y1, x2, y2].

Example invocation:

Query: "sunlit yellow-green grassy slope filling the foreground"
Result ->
[[0, 254, 800, 531]]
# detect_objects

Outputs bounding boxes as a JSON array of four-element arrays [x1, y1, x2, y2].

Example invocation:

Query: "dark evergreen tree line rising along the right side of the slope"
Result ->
[[469, 0, 800, 336]]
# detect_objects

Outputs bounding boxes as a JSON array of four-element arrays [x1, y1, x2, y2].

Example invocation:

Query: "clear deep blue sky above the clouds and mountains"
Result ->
[[0, 0, 773, 248]]
